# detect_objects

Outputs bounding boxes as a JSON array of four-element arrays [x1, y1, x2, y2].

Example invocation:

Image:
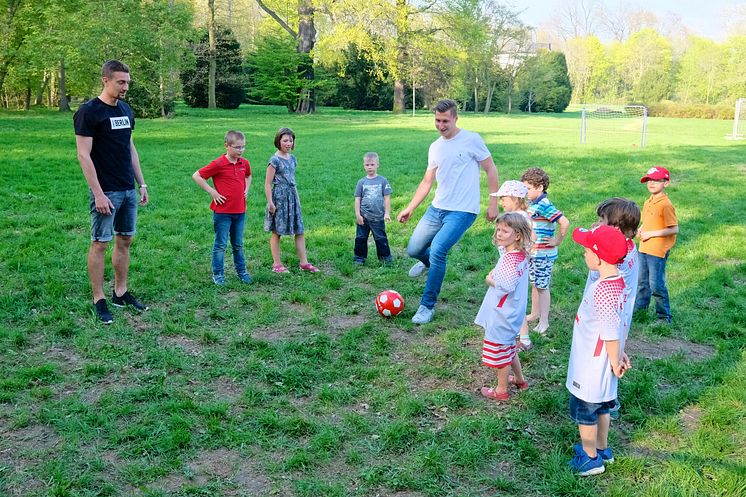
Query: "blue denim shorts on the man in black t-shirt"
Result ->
[[89, 188, 139, 242]]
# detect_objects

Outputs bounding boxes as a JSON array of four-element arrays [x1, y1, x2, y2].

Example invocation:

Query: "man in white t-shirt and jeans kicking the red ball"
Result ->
[[397, 100, 499, 324]]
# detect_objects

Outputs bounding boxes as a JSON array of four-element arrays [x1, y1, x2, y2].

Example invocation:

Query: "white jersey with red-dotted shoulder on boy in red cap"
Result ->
[[565, 276, 624, 403]]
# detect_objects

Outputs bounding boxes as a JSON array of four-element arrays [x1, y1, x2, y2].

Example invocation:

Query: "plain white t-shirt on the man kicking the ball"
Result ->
[[427, 129, 491, 214]]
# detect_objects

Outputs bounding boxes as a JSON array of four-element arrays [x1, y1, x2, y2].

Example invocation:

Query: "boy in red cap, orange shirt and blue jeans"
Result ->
[[635, 166, 679, 323]]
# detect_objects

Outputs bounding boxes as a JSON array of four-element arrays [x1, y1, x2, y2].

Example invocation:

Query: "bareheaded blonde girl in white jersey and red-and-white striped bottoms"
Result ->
[[474, 212, 531, 400]]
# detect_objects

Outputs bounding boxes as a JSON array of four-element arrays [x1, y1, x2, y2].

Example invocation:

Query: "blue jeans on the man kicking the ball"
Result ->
[[407, 205, 477, 309]]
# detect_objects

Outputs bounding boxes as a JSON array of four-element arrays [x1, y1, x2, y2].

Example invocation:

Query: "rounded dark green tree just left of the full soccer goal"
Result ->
[[517, 50, 572, 112]]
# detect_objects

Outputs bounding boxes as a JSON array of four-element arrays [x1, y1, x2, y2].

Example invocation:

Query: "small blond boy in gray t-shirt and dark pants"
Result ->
[[353, 152, 392, 264]]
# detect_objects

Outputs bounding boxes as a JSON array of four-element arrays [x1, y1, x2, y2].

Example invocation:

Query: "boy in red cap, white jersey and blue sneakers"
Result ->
[[565, 225, 629, 476]]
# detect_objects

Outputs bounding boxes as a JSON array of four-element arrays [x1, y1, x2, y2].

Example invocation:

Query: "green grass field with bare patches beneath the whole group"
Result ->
[[0, 102, 746, 497]]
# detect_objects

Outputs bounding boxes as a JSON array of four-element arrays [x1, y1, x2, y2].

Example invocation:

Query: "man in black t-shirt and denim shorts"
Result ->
[[73, 60, 148, 324]]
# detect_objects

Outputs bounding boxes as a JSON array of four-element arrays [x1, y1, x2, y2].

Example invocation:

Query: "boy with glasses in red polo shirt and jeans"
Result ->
[[192, 130, 251, 285]]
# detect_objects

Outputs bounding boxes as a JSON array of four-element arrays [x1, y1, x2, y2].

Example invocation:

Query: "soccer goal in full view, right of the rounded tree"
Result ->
[[580, 104, 648, 147]]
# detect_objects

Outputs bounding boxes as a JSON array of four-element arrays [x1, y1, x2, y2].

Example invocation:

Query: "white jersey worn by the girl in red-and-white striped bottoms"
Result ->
[[474, 251, 528, 345]]
